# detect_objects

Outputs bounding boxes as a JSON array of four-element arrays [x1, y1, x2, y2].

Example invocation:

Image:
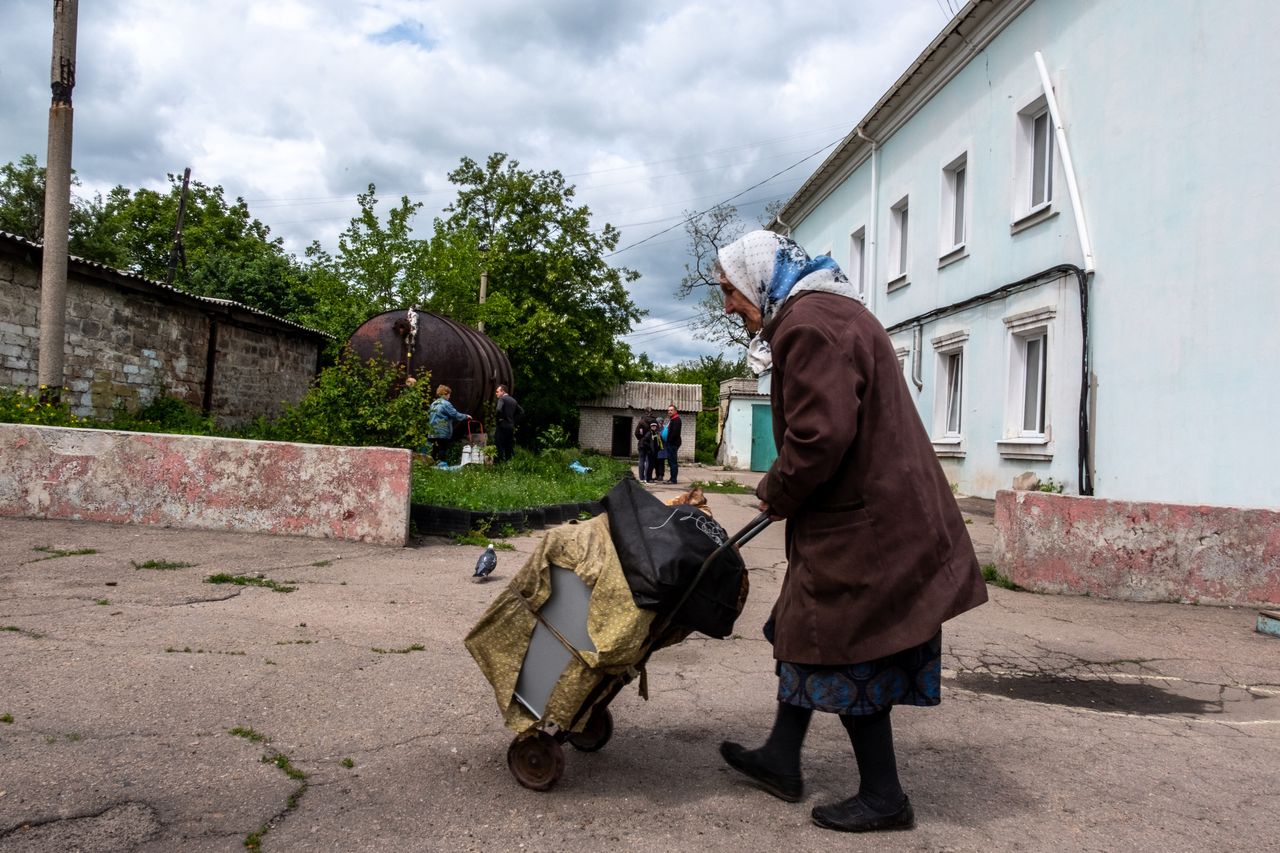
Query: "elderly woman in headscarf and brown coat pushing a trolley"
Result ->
[[717, 231, 987, 831]]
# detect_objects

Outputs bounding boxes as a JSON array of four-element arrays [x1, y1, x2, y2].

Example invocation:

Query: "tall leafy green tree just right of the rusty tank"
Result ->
[[426, 154, 641, 435]]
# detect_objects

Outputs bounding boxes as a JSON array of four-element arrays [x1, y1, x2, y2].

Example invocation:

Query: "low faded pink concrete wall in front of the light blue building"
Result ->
[[996, 492, 1280, 605]]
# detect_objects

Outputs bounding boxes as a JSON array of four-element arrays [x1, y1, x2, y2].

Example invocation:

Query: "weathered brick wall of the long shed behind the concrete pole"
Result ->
[[0, 237, 324, 425]]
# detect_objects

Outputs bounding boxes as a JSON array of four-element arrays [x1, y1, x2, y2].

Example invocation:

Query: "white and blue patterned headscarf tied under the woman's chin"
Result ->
[[717, 231, 860, 375]]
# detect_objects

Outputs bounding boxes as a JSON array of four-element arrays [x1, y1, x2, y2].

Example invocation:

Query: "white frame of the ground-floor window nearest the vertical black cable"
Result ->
[[997, 306, 1059, 460]]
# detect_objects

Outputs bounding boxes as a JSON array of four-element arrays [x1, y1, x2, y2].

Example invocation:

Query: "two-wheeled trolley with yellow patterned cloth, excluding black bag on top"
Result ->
[[466, 499, 769, 792]]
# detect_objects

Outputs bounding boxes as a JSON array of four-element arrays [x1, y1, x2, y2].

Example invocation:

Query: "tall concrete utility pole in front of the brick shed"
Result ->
[[36, 0, 79, 400]]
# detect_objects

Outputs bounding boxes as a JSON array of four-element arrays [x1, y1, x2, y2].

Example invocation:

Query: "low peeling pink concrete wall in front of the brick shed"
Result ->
[[0, 424, 410, 546]]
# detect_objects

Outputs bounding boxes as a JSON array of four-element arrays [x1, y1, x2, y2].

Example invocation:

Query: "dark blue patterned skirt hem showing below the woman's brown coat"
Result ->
[[765, 625, 942, 716]]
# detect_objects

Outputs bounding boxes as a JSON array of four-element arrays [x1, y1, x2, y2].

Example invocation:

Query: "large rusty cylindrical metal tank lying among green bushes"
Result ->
[[347, 309, 515, 420]]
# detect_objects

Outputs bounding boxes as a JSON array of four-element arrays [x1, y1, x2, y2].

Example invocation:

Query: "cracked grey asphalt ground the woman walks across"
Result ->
[[0, 466, 1280, 853]]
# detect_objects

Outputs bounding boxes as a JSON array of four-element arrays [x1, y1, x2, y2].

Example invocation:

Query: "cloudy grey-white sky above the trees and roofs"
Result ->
[[0, 0, 960, 364]]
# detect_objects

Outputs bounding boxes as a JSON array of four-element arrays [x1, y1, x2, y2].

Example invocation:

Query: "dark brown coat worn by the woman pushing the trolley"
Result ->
[[756, 292, 987, 665]]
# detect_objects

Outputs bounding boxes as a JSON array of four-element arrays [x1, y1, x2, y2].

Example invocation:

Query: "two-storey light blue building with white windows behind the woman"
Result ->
[[772, 0, 1280, 507]]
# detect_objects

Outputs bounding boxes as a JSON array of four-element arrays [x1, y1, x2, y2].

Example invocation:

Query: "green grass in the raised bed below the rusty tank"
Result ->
[[413, 450, 631, 511]]
